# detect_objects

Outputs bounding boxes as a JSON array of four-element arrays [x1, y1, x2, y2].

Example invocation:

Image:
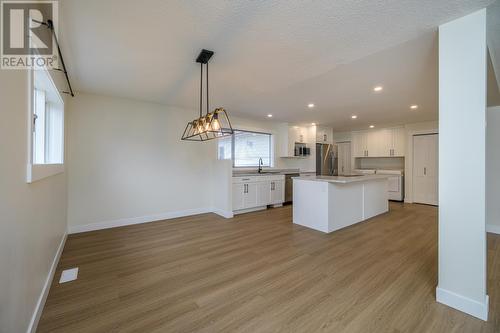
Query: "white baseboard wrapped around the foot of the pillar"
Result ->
[[436, 287, 489, 321]]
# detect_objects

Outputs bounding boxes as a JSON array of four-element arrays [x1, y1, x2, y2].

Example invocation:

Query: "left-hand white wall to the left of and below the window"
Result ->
[[0, 70, 66, 333]]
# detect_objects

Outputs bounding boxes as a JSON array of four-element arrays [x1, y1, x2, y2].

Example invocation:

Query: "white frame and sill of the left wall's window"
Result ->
[[26, 69, 66, 183]]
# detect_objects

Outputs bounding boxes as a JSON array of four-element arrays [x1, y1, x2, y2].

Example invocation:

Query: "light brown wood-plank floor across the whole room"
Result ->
[[38, 203, 500, 332]]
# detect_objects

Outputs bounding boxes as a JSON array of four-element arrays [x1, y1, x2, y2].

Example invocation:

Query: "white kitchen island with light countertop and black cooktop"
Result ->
[[293, 175, 389, 233]]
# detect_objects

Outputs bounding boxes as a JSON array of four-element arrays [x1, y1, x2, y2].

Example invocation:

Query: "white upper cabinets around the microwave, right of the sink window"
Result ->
[[279, 124, 316, 157]]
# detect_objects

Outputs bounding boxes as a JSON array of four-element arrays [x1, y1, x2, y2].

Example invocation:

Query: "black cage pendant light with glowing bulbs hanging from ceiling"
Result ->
[[181, 49, 233, 141]]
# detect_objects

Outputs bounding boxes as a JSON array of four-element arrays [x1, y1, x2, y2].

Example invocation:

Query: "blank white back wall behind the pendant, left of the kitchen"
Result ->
[[67, 94, 216, 232]]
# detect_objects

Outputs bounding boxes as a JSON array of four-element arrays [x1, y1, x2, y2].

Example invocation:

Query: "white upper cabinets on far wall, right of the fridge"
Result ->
[[352, 127, 406, 157]]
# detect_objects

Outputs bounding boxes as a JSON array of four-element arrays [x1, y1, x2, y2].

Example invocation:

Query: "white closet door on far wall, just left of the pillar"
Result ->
[[413, 134, 438, 205]]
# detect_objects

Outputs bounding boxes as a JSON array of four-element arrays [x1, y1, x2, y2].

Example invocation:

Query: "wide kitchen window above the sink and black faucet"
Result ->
[[217, 130, 272, 168]]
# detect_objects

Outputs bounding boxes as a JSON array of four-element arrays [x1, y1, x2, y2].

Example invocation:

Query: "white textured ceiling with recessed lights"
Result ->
[[61, 0, 492, 130]]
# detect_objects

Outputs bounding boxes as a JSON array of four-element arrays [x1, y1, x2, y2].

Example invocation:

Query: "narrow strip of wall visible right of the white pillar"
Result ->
[[486, 106, 500, 234]]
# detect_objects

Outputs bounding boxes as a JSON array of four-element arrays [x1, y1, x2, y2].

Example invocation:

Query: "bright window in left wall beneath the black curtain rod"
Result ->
[[27, 70, 64, 182]]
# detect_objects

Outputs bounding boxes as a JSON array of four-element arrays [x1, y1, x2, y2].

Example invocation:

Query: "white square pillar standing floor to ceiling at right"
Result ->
[[436, 9, 488, 320]]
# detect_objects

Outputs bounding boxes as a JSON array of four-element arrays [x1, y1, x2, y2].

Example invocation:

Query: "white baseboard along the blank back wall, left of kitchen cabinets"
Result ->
[[68, 208, 214, 234]]
